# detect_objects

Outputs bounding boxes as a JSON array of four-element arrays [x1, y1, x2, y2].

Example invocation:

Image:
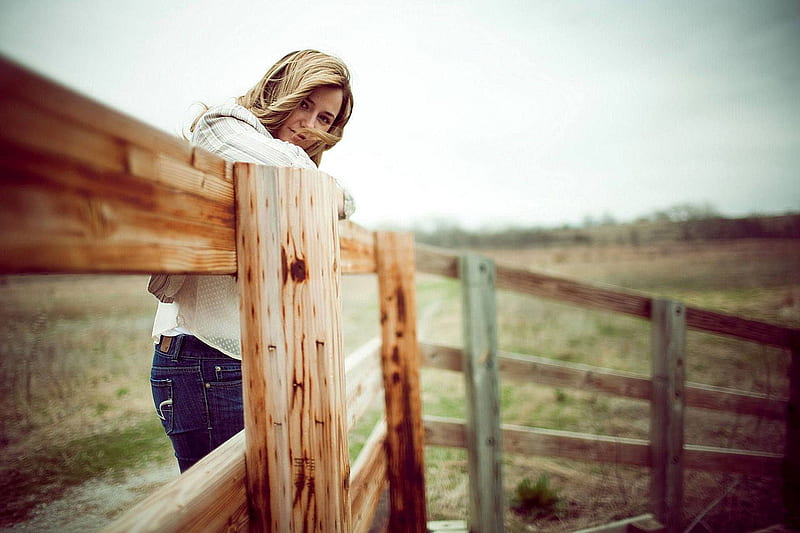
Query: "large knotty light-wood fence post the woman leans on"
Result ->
[[235, 164, 350, 533]]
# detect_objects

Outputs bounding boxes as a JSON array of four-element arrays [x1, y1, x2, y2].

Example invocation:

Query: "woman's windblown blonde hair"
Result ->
[[236, 50, 353, 165]]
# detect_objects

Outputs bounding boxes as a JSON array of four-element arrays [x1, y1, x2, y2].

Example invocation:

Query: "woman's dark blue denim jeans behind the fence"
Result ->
[[150, 335, 244, 472]]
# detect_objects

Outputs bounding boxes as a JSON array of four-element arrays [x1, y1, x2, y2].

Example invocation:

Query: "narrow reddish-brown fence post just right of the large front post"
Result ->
[[375, 232, 427, 533]]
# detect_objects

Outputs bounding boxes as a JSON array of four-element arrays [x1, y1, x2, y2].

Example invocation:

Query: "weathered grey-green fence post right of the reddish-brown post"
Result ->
[[458, 254, 504, 533]]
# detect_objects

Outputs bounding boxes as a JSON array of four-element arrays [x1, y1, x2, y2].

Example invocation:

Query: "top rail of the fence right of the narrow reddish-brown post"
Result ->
[[417, 245, 800, 347]]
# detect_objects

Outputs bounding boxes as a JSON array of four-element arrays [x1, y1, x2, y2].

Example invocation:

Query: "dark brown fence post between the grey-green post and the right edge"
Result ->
[[650, 299, 686, 533]]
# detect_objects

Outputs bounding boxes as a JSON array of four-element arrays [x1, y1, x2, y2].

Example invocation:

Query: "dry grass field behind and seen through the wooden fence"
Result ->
[[0, 240, 800, 532]]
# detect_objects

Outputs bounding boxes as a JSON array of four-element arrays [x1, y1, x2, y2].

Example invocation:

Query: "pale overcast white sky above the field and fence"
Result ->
[[0, 0, 800, 227]]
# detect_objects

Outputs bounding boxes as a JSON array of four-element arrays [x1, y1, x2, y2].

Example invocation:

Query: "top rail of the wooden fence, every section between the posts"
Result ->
[[0, 58, 800, 348]]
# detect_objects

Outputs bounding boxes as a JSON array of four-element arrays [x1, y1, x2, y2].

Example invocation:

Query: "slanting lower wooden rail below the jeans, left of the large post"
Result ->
[[104, 431, 249, 533]]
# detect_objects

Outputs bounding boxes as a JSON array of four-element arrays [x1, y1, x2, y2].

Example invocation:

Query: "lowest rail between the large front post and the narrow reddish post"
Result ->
[[350, 420, 388, 533]]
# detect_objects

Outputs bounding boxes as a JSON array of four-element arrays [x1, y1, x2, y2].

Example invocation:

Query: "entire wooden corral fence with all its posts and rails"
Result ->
[[0, 56, 800, 532]]
